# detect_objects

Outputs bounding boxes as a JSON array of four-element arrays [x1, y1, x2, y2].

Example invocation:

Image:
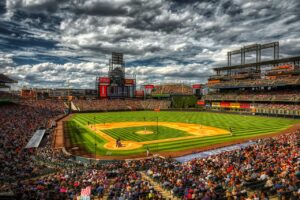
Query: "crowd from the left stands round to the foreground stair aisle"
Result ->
[[0, 100, 161, 200]]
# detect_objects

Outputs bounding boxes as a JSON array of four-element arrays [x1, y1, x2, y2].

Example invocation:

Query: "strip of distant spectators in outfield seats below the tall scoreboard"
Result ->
[[72, 99, 171, 111]]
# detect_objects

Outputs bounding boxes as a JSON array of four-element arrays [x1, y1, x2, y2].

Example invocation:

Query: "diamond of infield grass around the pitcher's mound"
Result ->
[[103, 126, 191, 142]]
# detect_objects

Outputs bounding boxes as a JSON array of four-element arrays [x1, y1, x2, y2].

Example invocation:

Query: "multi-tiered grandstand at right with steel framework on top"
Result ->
[[204, 42, 300, 116]]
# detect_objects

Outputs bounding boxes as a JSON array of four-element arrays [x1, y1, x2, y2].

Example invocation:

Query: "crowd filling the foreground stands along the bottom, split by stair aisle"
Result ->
[[4, 131, 300, 200]]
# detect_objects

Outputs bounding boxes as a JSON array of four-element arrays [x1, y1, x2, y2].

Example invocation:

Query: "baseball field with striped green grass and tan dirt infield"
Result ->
[[64, 111, 300, 156]]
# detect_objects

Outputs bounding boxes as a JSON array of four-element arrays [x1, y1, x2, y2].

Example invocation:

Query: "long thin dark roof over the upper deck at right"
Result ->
[[214, 56, 300, 71]]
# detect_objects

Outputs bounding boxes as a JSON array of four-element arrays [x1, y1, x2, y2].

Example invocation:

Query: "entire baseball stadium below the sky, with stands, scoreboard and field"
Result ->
[[0, 42, 300, 199]]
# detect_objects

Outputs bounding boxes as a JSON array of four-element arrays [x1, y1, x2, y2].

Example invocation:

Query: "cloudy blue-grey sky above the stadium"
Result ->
[[0, 0, 300, 88]]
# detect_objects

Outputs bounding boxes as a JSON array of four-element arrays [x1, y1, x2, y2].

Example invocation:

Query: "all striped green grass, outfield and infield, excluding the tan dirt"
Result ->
[[66, 111, 300, 155]]
